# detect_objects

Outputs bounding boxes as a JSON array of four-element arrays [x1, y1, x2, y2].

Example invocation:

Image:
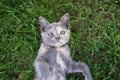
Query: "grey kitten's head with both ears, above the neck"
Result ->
[[39, 13, 70, 47]]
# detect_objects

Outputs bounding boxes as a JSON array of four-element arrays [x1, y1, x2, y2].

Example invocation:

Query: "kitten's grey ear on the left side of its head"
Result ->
[[39, 16, 49, 32]]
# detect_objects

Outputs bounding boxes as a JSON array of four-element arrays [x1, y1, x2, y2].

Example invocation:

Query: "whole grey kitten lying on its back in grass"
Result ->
[[34, 13, 92, 80]]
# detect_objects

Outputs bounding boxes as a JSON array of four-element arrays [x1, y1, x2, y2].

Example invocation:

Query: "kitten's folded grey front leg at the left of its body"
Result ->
[[34, 57, 51, 80]]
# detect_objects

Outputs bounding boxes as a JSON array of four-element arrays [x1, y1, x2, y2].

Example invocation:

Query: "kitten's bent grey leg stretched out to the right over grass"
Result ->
[[68, 62, 92, 80]]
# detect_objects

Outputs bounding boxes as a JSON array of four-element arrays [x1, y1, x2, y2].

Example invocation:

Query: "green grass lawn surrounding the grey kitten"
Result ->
[[0, 0, 120, 80]]
